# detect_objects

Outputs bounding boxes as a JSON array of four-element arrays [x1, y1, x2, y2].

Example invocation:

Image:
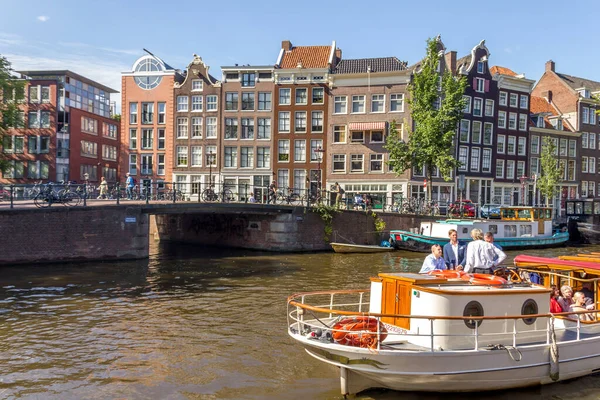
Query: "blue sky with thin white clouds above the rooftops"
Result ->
[[0, 0, 600, 112]]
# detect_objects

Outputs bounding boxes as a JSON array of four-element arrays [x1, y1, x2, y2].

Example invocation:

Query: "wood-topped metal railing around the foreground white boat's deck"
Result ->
[[287, 289, 600, 352]]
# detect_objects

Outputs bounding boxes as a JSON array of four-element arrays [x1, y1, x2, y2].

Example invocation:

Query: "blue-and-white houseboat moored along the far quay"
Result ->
[[390, 206, 569, 252]]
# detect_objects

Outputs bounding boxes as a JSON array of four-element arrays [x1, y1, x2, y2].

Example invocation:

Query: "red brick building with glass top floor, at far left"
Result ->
[[0, 70, 120, 184]]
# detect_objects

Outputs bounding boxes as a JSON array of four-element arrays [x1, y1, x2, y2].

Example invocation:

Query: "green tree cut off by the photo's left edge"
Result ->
[[0, 55, 25, 172]]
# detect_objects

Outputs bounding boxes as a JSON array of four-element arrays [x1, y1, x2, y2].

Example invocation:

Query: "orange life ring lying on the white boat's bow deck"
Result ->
[[332, 317, 387, 349]]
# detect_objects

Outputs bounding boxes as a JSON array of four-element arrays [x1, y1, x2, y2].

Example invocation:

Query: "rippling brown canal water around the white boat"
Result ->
[[0, 245, 600, 400]]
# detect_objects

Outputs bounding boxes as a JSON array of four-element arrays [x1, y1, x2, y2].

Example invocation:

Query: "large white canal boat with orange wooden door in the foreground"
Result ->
[[287, 264, 600, 395]]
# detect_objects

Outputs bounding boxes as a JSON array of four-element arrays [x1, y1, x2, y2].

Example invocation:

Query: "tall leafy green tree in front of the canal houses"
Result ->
[[385, 37, 467, 199]]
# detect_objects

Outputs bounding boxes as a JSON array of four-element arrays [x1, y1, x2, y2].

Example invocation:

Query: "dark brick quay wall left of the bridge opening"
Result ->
[[0, 205, 149, 265]]
